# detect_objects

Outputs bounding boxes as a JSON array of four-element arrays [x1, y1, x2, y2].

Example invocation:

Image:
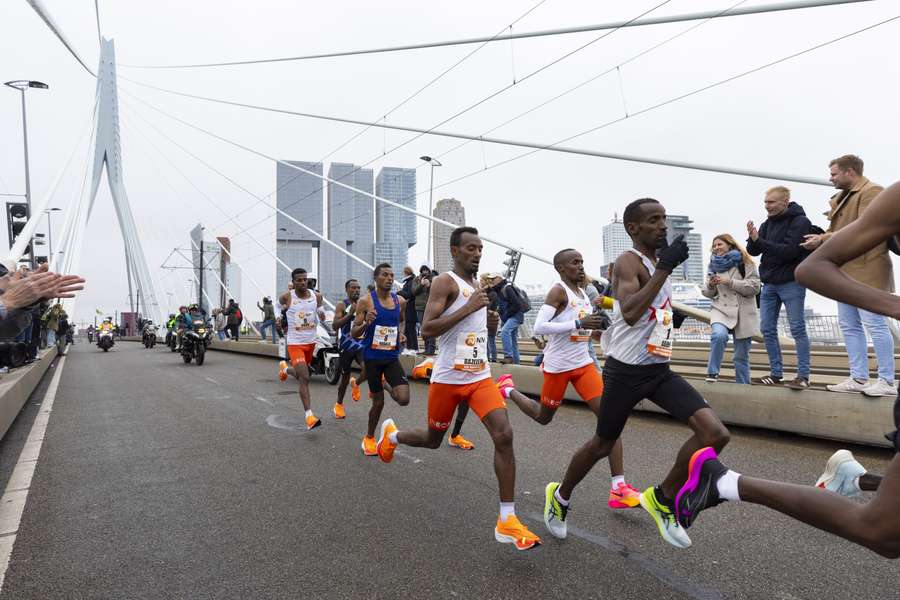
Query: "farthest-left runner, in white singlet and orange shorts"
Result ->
[[278, 268, 325, 430]]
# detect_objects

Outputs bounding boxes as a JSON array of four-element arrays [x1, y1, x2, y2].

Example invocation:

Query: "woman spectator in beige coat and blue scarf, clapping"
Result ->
[[702, 233, 762, 384]]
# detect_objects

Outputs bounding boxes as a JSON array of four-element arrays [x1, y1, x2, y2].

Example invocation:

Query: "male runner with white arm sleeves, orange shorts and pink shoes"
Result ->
[[497, 248, 641, 509]]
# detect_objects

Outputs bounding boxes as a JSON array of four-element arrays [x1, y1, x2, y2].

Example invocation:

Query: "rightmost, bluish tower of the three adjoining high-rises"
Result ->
[[373, 167, 418, 278]]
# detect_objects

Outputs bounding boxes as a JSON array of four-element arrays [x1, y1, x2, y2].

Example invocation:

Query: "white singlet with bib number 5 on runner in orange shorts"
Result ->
[[431, 271, 491, 385]]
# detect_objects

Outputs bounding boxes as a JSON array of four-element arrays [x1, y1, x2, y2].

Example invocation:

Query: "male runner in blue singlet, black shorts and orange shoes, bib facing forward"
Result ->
[[350, 263, 409, 456]]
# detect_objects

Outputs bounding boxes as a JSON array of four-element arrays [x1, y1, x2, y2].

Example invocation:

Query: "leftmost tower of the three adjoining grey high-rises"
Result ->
[[278, 161, 325, 298]]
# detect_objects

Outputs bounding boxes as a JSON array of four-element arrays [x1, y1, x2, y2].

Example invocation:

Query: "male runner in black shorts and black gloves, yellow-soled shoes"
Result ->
[[544, 198, 728, 548]]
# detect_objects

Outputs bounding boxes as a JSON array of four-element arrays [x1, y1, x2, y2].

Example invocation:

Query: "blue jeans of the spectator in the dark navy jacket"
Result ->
[[759, 281, 809, 379]]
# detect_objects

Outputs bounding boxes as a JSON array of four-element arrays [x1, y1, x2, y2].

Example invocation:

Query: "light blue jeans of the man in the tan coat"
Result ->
[[838, 302, 894, 383]]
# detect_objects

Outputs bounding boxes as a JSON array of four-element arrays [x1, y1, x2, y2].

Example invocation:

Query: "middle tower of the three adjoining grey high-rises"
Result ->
[[318, 163, 375, 304]]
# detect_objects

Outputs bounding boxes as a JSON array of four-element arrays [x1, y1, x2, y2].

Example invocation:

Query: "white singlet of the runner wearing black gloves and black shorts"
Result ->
[[601, 248, 673, 365]]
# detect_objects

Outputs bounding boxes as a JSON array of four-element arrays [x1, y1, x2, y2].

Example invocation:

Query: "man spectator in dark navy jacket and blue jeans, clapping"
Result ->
[[747, 186, 812, 390]]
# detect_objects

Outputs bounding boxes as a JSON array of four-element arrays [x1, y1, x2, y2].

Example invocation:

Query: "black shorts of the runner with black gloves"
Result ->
[[597, 358, 709, 440]]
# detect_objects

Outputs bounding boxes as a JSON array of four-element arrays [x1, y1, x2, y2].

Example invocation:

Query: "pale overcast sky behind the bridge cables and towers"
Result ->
[[0, 0, 900, 320]]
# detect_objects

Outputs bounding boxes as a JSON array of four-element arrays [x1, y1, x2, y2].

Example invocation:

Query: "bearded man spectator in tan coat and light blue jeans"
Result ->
[[803, 154, 897, 397]]
